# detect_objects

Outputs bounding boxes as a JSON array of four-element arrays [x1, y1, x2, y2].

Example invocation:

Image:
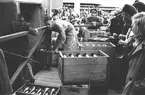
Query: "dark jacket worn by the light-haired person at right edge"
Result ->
[[123, 41, 145, 95]]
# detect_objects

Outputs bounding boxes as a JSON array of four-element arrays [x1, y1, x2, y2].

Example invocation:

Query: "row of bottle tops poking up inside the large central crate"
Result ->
[[63, 53, 100, 58]]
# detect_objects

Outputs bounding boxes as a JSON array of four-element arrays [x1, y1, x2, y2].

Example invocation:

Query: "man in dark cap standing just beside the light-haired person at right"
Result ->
[[115, 4, 137, 93]]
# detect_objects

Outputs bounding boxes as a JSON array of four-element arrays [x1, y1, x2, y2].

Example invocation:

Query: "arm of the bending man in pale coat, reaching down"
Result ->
[[53, 27, 66, 51]]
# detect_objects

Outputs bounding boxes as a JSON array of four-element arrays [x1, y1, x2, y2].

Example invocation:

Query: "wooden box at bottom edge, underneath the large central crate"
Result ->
[[60, 84, 90, 95]]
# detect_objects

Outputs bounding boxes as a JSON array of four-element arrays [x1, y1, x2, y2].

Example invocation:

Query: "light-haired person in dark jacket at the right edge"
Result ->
[[122, 12, 145, 95]]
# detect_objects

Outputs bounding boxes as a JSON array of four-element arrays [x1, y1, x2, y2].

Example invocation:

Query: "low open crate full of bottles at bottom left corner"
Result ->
[[16, 84, 60, 95]]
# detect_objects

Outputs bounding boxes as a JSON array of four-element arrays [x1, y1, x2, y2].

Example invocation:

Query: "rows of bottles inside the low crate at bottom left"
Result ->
[[20, 86, 58, 95]]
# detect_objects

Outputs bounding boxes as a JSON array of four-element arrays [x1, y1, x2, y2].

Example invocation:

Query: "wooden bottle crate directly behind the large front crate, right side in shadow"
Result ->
[[80, 42, 117, 85]]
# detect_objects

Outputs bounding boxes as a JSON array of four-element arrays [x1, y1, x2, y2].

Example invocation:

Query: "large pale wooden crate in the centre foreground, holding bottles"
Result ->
[[58, 50, 109, 84]]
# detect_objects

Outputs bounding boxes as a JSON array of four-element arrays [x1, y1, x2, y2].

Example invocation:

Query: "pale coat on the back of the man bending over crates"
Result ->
[[51, 19, 78, 50]]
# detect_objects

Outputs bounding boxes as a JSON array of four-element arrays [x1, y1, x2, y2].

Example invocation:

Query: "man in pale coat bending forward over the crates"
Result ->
[[44, 16, 79, 52]]
